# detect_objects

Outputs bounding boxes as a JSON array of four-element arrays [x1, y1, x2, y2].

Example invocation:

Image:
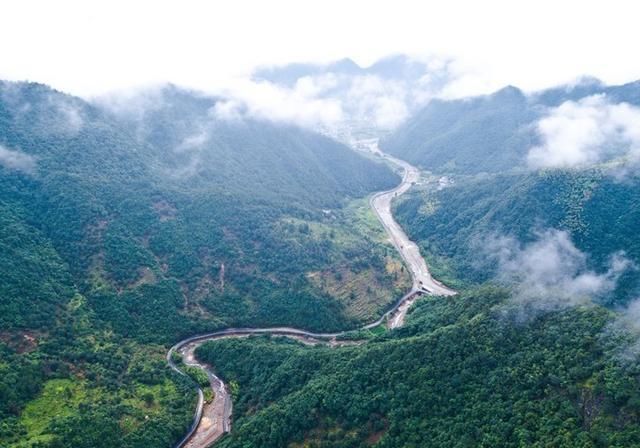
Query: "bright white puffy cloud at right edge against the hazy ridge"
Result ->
[[527, 95, 640, 168]]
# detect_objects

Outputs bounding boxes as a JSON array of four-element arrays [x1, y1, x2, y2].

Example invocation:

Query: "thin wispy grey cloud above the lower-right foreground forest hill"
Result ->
[[487, 229, 632, 313]]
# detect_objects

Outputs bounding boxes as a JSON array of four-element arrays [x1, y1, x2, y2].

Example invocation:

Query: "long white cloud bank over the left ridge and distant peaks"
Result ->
[[94, 56, 453, 144]]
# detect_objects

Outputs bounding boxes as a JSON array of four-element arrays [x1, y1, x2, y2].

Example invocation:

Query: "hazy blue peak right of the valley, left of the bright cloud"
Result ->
[[380, 87, 537, 172]]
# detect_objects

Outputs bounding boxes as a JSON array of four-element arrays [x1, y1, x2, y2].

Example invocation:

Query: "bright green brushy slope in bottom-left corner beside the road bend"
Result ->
[[0, 322, 195, 448]]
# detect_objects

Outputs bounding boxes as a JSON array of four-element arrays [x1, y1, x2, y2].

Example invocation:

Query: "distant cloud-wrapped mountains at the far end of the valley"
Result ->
[[252, 55, 450, 139]]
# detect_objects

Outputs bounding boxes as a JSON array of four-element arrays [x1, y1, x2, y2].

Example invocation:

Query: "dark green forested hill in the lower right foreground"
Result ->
[[197, 287, 640, 447]]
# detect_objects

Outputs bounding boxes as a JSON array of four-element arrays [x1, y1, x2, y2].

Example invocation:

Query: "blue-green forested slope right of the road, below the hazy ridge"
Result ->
[[394, 170, 640, 302]]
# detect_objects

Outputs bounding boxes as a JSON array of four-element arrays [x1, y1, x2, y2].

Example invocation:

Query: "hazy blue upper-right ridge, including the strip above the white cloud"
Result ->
[[380, 80, 640, 174]]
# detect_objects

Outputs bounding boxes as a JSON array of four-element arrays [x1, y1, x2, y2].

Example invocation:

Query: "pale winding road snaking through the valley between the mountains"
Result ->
[[167, 142, 456, 448]]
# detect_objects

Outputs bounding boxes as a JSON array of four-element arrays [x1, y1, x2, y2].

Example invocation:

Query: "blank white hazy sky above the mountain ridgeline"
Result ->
[[0, 0, 640, 95]]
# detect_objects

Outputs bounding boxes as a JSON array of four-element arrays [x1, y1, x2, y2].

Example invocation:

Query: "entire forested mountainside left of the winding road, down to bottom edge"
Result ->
[[0, 82, 408, 447]]
